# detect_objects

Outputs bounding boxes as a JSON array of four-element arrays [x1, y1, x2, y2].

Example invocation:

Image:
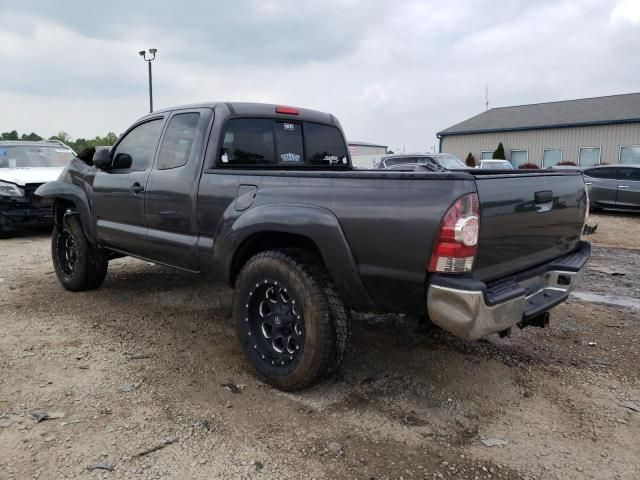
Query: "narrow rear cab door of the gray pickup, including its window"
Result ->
[[145, 108, 213, 271]]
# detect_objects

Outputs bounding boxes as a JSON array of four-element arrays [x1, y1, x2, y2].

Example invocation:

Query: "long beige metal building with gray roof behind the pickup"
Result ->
[[437, 93, 640, 167]]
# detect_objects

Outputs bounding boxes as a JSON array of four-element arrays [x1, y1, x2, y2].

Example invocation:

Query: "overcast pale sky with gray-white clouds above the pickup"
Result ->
[[0, 0, 640, 151]]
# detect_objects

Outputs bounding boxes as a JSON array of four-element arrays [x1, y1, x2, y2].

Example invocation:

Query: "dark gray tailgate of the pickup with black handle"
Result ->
[[474, 171, 587, 281]]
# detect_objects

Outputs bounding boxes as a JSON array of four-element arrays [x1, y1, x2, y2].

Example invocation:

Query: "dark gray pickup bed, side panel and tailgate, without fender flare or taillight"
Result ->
[[198, 168, 585, 312]]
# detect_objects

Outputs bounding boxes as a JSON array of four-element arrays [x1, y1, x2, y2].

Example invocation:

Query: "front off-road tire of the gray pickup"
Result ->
[[51, 215, 109, 292]]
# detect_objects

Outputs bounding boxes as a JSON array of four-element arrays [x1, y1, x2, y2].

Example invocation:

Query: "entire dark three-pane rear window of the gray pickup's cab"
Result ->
[[217, 118, 349, 168]]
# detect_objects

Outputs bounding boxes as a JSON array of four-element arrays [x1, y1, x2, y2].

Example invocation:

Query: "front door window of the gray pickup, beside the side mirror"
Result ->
[[113, 118, 162, 170]]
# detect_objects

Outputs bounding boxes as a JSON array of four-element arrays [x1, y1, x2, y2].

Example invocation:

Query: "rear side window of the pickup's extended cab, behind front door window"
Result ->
[[156, 112, 200, 170]]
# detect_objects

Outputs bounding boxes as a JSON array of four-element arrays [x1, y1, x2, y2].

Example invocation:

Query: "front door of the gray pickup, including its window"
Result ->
[[92, 117, 164, 256]]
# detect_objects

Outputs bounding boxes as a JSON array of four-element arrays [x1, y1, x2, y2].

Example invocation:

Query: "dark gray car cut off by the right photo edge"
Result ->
[[583, 165, 640, 210]]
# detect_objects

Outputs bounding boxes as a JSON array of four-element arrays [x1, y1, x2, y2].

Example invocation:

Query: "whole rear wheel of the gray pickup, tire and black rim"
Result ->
[[234, 250, 350, 391]]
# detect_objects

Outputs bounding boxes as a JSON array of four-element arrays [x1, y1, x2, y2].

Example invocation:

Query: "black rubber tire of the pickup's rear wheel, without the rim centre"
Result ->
[[234, 249, 351, 391]]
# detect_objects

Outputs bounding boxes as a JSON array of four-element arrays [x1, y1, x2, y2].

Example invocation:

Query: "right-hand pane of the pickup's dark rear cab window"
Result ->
[[304, 122, 348, 166]]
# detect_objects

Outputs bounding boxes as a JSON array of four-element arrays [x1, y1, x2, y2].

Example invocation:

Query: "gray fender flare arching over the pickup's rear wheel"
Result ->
[[214, 204, 373, 311]]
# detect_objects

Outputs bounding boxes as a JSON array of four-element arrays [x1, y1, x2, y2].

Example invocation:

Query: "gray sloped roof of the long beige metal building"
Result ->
[[437, 93, 640, 137]]
